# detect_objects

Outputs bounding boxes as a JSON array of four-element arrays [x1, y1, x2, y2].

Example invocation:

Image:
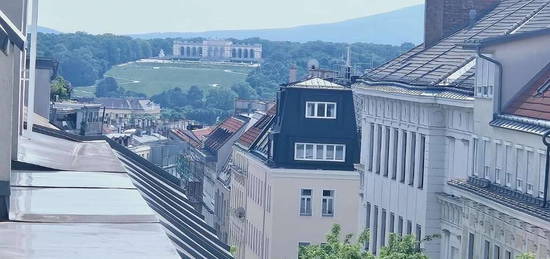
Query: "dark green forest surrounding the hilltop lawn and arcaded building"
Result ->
[[38, 33, 414, 123]]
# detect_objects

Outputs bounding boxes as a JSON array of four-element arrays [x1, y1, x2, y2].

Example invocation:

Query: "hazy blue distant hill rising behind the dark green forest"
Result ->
[[130, 5, 424, 45]]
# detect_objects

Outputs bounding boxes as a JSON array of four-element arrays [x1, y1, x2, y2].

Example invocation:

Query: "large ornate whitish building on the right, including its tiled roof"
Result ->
[[355, 0, 550, 259]]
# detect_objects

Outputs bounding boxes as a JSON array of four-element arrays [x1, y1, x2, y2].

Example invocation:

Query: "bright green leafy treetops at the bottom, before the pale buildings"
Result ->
[[299, 225, 437, 259]]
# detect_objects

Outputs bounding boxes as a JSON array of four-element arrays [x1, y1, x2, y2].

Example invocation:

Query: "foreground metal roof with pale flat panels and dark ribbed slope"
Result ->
[[12, 125, 232, 259]]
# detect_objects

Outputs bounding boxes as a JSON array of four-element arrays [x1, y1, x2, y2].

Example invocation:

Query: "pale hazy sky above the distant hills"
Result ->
[[38, 0, 424, 34]]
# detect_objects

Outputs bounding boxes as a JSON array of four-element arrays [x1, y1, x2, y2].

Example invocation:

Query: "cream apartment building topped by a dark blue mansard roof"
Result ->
[[229, 78, 359, 259]]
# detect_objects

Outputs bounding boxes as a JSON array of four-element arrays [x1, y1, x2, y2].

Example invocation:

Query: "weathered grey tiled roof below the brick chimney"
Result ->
[[363, 0, 550, 92]]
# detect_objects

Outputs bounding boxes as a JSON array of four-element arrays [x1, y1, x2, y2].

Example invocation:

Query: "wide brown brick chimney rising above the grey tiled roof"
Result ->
[[424, 0, 500, 48]]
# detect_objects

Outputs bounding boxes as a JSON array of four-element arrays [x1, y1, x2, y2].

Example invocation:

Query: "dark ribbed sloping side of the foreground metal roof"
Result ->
[[30, 125, 233, 259]]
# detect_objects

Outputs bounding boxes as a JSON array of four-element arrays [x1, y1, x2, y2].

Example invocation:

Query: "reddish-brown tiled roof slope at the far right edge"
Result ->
[[505, 64, 550, 121]]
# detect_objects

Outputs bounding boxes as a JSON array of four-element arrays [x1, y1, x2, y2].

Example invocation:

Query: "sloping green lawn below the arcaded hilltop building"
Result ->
[[105, 62, 253, 96]]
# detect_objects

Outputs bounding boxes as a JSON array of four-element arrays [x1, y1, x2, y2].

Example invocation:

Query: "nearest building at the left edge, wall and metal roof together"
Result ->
[[0, 0, 232, 259]]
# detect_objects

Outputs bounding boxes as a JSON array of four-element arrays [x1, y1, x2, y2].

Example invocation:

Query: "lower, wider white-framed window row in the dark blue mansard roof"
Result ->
[[294, 143, 346, 162]]
